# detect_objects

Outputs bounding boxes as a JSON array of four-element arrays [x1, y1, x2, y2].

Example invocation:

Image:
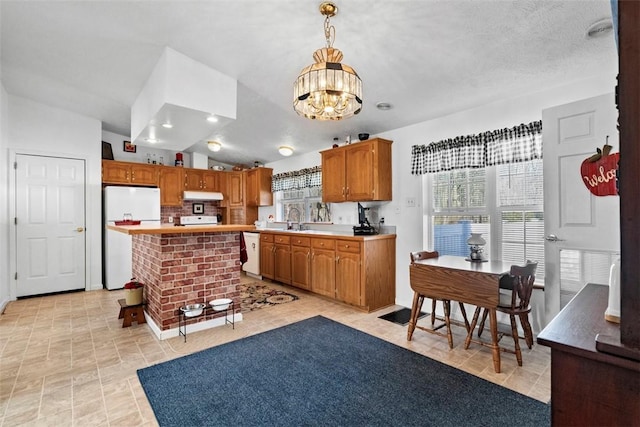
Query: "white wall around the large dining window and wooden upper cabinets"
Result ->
[[260, 73, 616, 320]]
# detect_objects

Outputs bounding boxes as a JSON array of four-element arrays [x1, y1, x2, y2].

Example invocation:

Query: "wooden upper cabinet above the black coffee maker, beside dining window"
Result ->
[[321, 138, 392, 202]]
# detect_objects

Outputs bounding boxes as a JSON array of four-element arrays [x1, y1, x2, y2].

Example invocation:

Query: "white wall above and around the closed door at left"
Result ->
[[2, 95, 102, 300]]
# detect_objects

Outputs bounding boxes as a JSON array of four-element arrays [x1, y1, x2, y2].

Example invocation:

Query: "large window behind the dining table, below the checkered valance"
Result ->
[[424, 159, 544, 283]]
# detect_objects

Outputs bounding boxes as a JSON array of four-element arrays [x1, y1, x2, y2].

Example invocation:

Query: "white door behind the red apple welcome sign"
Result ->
[[542, 94, 620, 323]]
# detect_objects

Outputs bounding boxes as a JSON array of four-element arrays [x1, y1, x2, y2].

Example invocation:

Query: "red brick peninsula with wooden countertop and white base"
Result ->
[[107, 224, 255, 339]]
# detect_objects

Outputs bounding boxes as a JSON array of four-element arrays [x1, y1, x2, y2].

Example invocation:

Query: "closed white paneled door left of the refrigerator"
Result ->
[[15, 155, 86, 297]]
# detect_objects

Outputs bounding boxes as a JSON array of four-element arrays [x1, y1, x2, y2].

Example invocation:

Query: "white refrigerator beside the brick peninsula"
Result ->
[[102, 186, 160, 290]]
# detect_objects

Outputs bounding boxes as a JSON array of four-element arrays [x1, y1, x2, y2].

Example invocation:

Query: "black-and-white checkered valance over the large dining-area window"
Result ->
[[411, 121, 542, 175]]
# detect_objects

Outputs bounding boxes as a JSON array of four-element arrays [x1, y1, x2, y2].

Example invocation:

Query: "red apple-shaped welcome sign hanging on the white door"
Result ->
[[580, 144, 620, 196]]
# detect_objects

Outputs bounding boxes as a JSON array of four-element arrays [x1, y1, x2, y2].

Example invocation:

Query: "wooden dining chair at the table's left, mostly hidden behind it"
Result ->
[[407, 251, 468, 348]]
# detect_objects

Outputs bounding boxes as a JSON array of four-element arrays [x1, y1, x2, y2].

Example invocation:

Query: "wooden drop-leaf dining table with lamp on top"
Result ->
[[408, 255, 511, 373]]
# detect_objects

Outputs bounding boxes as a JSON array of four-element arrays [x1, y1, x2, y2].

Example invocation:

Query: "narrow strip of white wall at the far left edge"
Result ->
[[0, 83, 10, 313]]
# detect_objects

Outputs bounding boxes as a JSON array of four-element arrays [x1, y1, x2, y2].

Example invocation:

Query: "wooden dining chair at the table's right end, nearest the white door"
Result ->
[[472, 261, 538, 366]]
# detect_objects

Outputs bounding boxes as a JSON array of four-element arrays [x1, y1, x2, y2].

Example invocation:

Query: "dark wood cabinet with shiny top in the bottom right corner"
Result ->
[[537, 284, 640, 426]]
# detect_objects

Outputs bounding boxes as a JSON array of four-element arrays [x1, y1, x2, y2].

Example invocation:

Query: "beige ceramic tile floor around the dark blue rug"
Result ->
[[0, 277, 551, 426]]
